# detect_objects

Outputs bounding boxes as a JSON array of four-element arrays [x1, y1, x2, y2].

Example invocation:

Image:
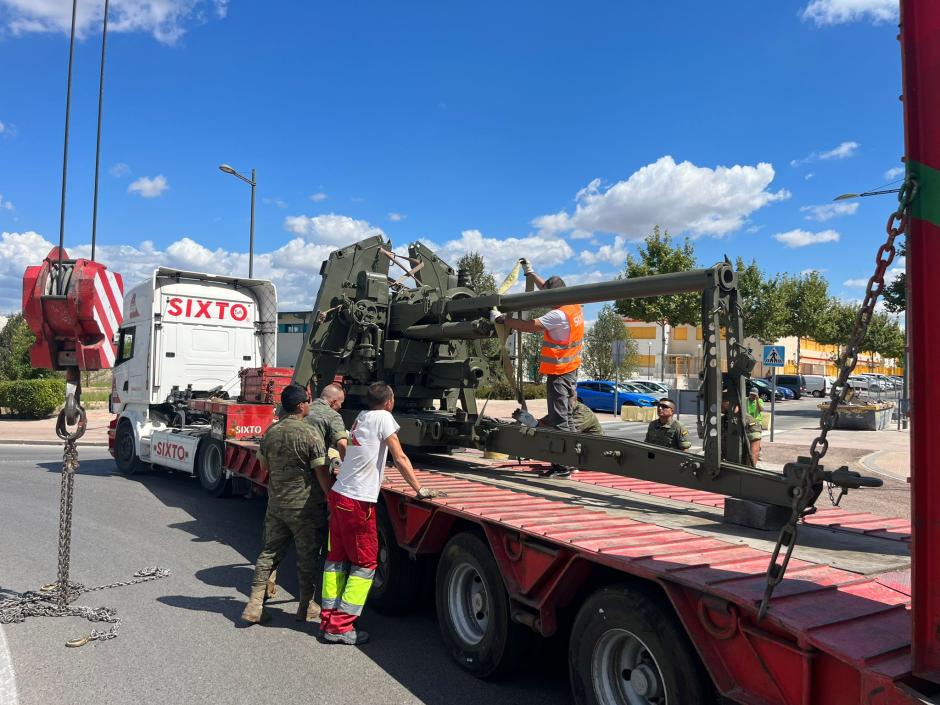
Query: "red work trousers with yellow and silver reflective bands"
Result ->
[[320, 492, 379, 634]]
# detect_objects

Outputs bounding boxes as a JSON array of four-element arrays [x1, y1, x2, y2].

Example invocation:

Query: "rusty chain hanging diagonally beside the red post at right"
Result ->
[[757, 176, 917, 621]]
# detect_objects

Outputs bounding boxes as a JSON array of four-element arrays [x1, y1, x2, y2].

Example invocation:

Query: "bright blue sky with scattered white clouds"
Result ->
[[0, 0, 903, 311]]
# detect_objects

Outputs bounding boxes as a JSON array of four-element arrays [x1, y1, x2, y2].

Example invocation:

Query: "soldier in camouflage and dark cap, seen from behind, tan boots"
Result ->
[[242, 384, 329, 624]]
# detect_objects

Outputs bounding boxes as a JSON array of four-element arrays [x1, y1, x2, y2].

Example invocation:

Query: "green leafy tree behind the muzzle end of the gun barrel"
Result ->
[[616, 225, 702, 377]]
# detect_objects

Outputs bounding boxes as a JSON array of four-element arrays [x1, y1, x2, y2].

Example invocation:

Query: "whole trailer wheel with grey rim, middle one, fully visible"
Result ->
[[434, 533, 534, 678]]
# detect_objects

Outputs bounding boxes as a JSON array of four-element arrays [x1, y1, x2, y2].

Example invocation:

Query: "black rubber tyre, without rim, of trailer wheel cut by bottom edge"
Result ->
[[568, 585, 715, 705]]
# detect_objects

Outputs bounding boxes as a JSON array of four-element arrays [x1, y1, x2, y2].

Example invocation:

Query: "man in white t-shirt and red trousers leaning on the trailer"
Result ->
[[320, 382, 442, 644]]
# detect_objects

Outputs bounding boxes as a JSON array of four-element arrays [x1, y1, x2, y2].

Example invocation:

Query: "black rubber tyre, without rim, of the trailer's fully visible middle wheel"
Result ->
[[434, 532, 536, 678]]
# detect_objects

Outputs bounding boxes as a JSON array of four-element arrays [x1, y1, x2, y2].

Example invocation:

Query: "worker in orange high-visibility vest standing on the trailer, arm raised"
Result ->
[[490, 260, 584, 477]]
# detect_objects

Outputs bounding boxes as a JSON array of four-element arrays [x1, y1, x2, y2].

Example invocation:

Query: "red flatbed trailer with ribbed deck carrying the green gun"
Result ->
[[211, 424, 916, 705]]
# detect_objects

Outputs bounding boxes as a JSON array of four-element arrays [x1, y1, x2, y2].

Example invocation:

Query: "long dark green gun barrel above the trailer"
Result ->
[[447, 264, 737, 313]]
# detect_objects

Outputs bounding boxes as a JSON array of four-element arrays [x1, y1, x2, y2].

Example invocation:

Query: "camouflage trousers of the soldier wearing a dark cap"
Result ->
[[251, 505, 326, 598]]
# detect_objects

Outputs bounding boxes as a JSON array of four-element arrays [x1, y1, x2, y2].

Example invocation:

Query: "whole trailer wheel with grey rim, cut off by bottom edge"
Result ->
[[568, 585, 712, 705]]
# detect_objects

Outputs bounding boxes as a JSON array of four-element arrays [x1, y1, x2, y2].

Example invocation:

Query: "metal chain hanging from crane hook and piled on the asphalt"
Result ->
[[0, 388, 170, 647]]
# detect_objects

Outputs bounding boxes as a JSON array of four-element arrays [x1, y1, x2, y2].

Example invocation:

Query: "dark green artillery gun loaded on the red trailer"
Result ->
[[294, 236, 880, 507]]
